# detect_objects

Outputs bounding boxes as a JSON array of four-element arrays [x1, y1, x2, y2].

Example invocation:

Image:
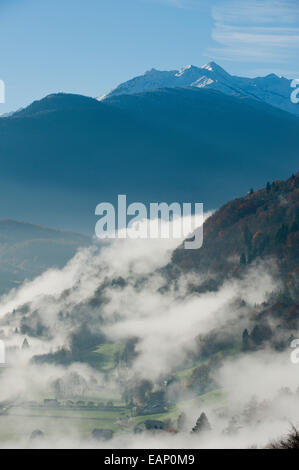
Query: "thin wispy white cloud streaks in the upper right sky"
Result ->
[[208, 0, 299, 63]]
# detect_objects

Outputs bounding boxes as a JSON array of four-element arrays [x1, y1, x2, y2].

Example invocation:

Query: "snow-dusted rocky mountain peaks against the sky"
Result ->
[[98, 62, 299, 116]]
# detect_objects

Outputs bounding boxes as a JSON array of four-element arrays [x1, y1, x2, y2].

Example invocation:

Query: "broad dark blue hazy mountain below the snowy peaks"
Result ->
[[0, 72, 299, 234]]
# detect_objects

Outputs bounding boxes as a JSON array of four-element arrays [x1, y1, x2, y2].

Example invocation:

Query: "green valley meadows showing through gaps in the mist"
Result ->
[[0, 343, 232, 445]]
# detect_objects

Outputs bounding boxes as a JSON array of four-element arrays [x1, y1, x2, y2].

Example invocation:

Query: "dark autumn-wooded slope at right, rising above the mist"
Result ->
[[170, 173, 299, 284]]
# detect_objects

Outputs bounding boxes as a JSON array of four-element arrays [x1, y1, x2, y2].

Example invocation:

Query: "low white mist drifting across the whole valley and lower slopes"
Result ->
[[0, 217, 299, 448]]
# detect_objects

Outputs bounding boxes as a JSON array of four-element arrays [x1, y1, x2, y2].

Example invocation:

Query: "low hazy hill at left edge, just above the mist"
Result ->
[[0, 220, 91, 295]]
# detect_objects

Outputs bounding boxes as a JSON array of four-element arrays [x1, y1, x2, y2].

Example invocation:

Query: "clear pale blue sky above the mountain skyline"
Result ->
[[0, 0, 299, 113]]
